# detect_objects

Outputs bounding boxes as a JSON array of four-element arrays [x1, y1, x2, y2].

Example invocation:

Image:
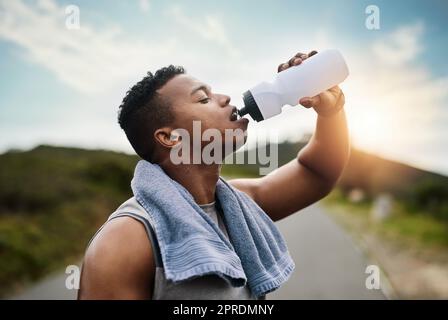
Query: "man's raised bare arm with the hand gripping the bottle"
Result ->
[[230, 51, 350, 221]]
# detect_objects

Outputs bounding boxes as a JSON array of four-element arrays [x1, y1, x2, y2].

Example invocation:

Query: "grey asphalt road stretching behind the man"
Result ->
[[11, 205, 385, 300]]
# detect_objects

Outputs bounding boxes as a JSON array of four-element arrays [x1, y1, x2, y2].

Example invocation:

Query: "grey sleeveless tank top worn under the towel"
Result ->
[[89, 197, 266, 300]]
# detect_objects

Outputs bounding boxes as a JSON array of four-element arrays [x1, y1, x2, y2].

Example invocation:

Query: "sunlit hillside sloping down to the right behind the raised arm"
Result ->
[[228, 142, 448, 221]]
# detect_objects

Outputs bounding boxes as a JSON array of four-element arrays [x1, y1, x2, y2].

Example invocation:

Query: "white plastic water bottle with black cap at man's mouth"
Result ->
[[238, 49, 349, 121]]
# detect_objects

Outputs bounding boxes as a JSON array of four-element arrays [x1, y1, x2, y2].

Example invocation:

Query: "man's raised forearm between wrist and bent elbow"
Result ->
[[297, 109, 350, 184]]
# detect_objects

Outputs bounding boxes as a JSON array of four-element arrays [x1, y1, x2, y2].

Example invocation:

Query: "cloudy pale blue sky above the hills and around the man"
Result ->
[[0, 0, 448, 174]]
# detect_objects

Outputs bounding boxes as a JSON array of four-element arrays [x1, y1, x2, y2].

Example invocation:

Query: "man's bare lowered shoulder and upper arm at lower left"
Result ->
[[80, 216, 155, 299]]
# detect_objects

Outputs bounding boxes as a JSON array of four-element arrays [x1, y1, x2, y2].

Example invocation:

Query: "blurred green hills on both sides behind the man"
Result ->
[[0, 143, 448, 295]]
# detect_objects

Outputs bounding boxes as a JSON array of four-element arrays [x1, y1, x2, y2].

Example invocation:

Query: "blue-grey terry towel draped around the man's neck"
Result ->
[[131, 160, 294, 297]]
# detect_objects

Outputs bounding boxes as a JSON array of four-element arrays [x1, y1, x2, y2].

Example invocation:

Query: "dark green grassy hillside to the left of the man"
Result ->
[[0, 146, 137, 296]]
